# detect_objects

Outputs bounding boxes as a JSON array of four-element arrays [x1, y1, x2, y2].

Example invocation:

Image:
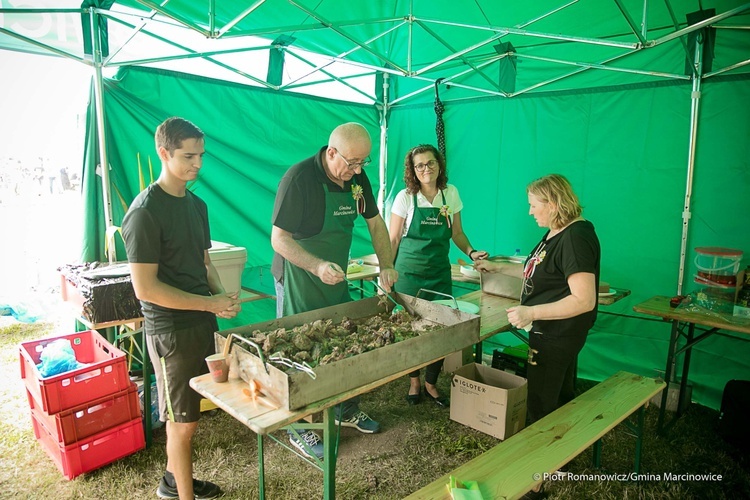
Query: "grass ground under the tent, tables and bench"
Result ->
[[0, 322, 750, 499]]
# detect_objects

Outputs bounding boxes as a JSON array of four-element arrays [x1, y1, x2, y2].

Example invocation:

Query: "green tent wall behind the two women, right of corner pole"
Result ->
[[386, 78, 750, 408]]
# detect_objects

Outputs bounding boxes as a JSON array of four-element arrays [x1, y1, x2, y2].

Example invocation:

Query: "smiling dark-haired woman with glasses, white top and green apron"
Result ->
[[388, 144, 487, 408]]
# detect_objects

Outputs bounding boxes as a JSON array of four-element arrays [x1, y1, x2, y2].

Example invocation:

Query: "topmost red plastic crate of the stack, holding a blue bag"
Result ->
[[19, 330, 130, 414]]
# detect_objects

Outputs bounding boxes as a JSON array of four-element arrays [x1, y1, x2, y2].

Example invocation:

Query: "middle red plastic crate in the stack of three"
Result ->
[[26, 384, 141, 446]]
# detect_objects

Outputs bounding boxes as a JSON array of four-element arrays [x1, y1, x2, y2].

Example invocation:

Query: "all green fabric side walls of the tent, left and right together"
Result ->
[[86, 68, 750, 408]]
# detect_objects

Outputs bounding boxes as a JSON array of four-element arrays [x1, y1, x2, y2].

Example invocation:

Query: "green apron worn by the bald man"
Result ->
[[284, 182, 357, 316]]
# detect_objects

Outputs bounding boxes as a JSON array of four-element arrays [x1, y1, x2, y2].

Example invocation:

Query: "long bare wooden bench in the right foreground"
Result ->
[[407, 372, 665, 500]]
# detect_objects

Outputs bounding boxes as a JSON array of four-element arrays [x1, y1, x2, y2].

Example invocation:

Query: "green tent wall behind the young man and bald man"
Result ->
[[84, 69, 379, 267]]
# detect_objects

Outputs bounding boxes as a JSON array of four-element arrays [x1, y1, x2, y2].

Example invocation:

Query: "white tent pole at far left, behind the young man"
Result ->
[[89, 9, 115, 263]]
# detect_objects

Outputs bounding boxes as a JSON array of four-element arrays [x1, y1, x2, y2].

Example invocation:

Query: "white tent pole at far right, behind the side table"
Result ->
[[677, 34, 704, 295]]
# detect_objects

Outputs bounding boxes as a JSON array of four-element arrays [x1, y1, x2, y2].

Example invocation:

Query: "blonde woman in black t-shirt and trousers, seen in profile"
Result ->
[[474, 174, 601, 422]]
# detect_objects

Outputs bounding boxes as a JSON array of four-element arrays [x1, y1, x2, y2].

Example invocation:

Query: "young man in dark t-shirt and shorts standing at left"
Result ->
[[122, 118, 240, 499]]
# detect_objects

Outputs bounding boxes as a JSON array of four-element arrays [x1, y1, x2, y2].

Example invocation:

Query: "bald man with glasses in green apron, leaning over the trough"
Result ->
[[271, 123, 398, 458]]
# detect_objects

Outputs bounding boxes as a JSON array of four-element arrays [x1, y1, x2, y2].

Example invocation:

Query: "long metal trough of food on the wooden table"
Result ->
[[215, 293, 479, 410]]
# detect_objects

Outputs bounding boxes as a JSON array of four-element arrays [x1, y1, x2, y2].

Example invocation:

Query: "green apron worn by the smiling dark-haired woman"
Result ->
[[394, 191, 453, 300]]
